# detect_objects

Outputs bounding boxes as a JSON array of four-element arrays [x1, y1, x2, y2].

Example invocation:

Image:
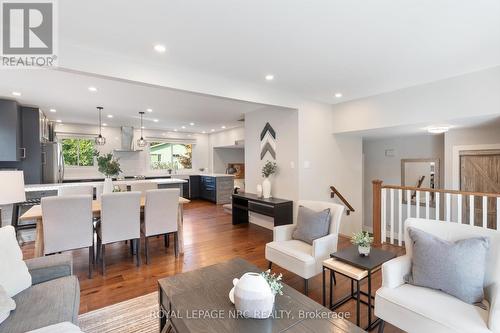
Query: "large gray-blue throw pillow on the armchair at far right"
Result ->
[[405, 226, 490, 304]]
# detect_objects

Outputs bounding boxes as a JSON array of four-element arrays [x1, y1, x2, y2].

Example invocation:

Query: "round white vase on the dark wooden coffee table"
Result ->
[[229, 273, 275, 319]]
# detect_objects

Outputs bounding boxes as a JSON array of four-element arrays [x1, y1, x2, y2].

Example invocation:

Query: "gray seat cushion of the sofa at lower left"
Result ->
[[0, 275, 80, 333]]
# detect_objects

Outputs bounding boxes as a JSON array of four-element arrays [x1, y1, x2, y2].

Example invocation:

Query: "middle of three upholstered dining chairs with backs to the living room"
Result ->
[[96, 192, 141, 275]]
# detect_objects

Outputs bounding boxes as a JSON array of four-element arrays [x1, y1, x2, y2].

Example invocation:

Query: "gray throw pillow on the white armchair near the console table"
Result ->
[[292, 206, 330, 245]]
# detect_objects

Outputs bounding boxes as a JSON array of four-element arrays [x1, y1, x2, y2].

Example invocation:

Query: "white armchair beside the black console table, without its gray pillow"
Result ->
[[266, 200, 344, 295]]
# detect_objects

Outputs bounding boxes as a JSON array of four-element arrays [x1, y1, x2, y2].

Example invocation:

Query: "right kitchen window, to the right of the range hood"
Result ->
[[149, 142, 193, 170]]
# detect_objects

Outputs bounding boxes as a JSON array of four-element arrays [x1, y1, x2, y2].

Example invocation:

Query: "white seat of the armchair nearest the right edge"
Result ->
[[375, 284, 491, 333]]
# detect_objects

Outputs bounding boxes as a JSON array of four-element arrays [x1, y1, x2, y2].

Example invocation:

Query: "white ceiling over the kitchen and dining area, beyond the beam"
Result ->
[[0, 70, 284, 133]]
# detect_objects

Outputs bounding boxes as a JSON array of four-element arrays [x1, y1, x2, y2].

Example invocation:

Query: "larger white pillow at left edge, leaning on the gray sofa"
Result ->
[[0, 225, 31, 297]]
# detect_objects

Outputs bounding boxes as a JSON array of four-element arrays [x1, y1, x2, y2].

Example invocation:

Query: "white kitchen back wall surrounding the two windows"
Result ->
[[56, 124, 211, 179]]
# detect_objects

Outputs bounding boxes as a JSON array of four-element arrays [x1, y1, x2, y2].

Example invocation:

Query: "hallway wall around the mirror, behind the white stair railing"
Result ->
[[363, 135, 445, 230]]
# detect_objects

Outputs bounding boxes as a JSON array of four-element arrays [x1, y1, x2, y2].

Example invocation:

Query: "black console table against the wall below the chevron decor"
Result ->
[[233, 193, 293, 226]]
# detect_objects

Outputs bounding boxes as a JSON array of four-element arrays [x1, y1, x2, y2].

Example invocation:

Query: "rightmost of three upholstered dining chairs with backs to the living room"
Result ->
[[141, 188, 180, 264]]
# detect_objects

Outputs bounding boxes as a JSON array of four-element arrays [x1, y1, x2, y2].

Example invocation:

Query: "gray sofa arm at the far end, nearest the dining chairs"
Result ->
[[25, 253, 73, 284]]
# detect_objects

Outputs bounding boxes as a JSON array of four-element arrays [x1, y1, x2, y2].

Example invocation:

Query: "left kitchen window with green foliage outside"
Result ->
[[62, 138, 94, 166]]
